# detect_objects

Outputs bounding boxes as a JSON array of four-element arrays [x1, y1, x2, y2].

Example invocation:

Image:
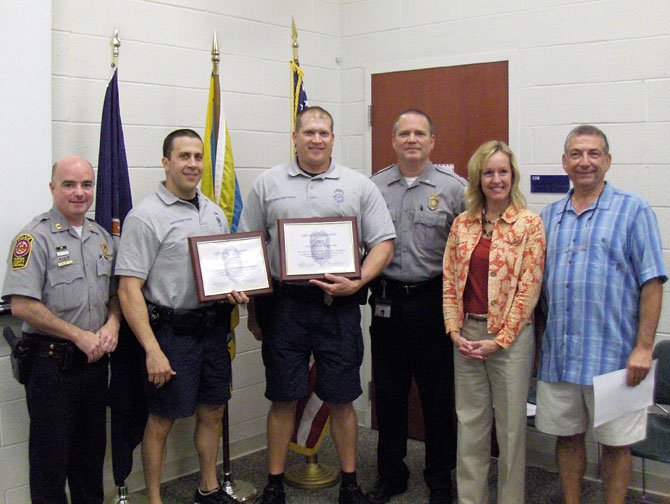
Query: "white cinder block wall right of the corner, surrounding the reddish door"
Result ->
[[341, 0, 670, 493]]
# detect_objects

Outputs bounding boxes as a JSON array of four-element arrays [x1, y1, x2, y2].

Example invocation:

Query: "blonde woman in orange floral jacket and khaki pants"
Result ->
[[443, 141, 546, 504]]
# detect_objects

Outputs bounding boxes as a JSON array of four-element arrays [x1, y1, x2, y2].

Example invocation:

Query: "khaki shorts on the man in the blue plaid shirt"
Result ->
[[535, 381, 647, 446]]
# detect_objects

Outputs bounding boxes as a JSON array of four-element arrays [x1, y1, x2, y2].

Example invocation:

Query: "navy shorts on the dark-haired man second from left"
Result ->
[[144, 324, 231, 419]]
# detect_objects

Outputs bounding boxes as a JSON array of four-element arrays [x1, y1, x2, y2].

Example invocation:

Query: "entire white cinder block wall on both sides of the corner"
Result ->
[[0, 0, 670, 504]]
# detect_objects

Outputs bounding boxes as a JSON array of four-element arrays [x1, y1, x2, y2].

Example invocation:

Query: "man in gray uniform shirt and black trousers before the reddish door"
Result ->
[[368, 109, 465, 504]]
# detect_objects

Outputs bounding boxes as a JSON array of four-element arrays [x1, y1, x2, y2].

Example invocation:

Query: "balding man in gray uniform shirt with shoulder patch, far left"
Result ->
[[3, 156, 120, 504]]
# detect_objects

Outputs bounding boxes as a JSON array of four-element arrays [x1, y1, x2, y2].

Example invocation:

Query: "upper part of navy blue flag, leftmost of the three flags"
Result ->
[[95, 70, 133, 241]]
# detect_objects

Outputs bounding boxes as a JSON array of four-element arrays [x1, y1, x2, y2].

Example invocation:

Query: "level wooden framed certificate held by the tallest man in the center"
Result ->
[[277, 217, 361, 282]]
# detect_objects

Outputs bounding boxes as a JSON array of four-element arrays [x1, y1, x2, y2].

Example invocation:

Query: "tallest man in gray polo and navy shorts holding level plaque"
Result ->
[[240, 107, 395, 504]]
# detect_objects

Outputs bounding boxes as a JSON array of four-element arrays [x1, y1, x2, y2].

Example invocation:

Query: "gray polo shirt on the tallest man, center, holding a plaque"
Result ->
[[239, 161, 395, 278]]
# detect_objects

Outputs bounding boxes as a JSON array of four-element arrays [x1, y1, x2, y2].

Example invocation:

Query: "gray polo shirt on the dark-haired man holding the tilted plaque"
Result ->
[[114, 182, 229, 309]]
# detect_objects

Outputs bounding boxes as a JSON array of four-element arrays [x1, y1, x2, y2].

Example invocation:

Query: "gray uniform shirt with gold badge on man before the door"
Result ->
[[372, 163, 466, 283]]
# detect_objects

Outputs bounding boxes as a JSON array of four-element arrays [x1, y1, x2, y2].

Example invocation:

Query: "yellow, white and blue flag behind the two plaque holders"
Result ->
[[200, 65, 242, 359]]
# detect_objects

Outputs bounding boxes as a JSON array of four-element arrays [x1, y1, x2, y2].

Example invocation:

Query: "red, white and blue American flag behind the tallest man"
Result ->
[[290, 60, 330, 456]]
